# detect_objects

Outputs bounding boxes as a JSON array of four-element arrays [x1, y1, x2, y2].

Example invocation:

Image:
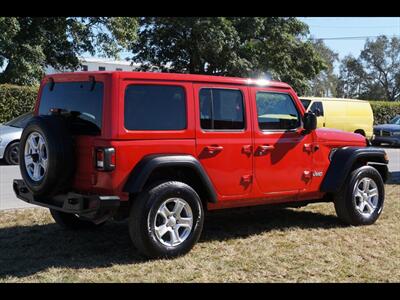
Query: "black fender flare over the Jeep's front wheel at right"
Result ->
[[320, 147, 389, 192]]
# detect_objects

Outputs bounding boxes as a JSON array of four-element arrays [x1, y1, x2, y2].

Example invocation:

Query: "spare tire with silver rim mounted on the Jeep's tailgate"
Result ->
[[19, 115, 75, 197]]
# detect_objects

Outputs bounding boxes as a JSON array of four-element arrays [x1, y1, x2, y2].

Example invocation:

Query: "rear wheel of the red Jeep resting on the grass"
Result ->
[[129, 181, 204, 258]]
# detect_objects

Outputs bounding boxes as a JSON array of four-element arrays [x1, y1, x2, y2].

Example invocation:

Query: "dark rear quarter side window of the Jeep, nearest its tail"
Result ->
[[125, 85, 186, 130]]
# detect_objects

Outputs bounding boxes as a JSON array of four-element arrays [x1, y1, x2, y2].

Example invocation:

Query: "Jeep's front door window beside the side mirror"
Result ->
[[256, 92, 300, 130]]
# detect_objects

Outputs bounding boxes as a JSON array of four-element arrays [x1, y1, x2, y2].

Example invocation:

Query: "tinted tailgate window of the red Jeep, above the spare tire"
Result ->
[[39, 81, 104, 135]]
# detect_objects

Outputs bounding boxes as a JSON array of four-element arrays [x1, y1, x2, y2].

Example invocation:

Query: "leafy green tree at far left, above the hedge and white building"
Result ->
[[0, 17, 138, 84]]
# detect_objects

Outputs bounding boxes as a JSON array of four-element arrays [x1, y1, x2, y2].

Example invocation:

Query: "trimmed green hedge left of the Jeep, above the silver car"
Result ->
[[0, 84, 38, 123]]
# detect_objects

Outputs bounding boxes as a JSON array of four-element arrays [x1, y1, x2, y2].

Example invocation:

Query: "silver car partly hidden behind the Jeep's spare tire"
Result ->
[[0, 112, 33, 165]]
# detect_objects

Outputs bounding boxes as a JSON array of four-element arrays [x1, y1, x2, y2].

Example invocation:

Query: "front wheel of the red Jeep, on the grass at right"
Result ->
[[334, 166, 385, 225]]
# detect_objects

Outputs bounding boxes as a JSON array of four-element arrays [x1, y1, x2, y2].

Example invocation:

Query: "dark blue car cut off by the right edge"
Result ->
[[372, 115, 400, 146]]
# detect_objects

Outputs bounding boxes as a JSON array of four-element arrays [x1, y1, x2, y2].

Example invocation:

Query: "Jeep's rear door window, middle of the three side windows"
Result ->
[[199, 88, 245, 130]]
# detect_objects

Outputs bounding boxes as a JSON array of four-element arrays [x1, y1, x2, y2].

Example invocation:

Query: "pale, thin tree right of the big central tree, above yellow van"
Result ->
[[309, 40, 339, 97]]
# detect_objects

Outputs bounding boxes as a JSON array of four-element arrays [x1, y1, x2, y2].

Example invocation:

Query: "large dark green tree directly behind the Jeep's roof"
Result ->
[[130, 17, 326, 92]]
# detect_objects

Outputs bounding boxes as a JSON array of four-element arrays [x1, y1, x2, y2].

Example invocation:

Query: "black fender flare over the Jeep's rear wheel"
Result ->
[[123, 154, 217, 203]]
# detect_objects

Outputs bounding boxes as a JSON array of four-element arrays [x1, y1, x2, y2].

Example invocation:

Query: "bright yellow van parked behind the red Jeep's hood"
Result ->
[[300, 97, 374, 139]]
